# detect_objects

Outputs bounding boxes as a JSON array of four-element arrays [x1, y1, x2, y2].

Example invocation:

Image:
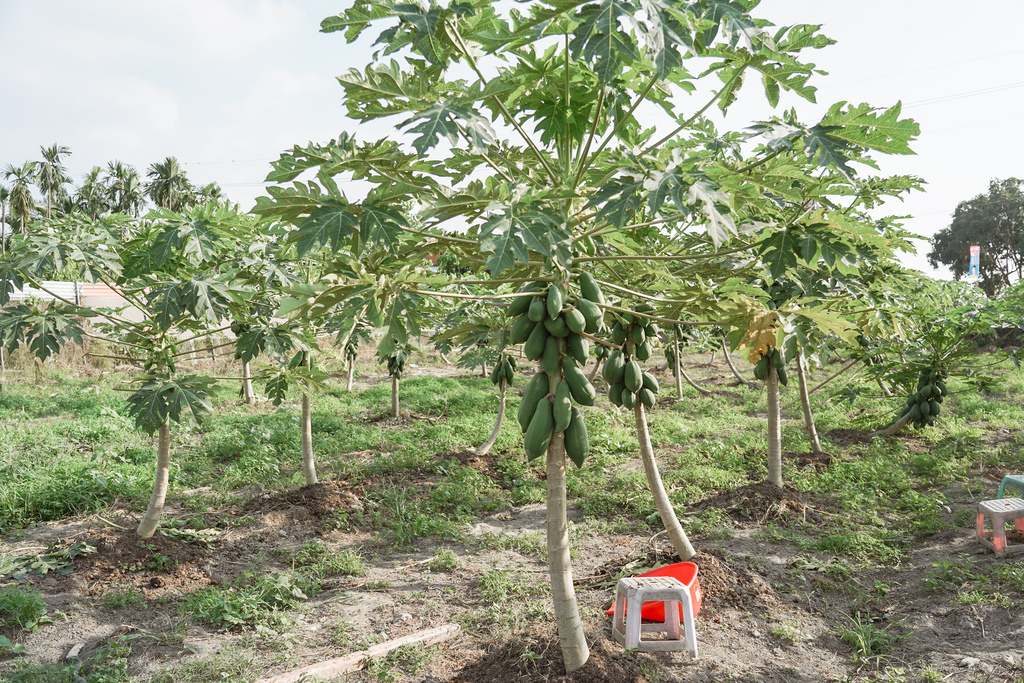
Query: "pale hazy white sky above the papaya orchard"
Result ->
[[0, 0, 1024, 276]]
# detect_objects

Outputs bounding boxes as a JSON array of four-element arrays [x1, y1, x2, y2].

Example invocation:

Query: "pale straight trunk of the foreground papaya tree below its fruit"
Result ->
[[547, 432, 590, 674]]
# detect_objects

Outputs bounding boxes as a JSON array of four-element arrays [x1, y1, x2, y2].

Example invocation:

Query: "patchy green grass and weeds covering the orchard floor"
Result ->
[[0, 352, 1024, 683]]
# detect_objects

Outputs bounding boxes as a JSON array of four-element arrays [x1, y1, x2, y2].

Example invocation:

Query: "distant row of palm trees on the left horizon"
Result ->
[[0, 144, 222, 248]]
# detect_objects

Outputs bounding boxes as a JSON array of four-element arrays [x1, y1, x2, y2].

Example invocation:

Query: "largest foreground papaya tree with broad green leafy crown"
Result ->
[[258, 0, 937, 671]]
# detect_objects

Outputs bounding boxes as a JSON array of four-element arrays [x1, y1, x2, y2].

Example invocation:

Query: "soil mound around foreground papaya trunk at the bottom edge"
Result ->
[[450, 636, 680, 683]]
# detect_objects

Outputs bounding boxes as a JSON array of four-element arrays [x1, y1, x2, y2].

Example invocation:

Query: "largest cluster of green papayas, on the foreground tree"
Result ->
[[509, 273, 604, 467]]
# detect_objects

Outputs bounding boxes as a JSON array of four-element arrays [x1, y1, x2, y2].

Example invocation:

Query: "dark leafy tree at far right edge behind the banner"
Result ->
[[928, 178, 1024, 296]]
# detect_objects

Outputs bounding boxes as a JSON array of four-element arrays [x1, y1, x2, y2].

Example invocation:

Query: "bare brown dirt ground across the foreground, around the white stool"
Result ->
[[0, 362, 1024, 683]]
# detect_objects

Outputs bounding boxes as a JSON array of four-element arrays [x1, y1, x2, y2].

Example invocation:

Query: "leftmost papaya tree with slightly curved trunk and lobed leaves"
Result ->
[[0, 206, 256, 538]]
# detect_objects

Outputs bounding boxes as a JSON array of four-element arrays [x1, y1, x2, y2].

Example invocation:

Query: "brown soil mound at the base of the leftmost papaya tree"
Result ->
[[73, 529, 213, 595]]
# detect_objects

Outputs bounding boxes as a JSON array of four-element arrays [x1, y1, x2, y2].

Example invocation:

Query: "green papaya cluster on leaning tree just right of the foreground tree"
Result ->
[[604, 304, 658, 410]]
